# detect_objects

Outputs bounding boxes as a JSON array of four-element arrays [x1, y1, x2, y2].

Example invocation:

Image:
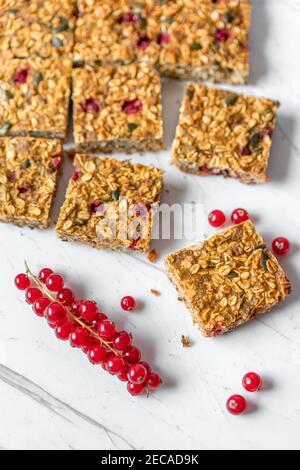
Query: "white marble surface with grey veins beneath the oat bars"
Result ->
[[0, 0, 300, 450]]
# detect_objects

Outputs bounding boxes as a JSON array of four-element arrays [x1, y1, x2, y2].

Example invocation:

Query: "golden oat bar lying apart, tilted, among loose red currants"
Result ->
[[165, 221, 291, 336]]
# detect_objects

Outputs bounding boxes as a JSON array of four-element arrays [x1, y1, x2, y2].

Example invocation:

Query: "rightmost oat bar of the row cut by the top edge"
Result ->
[[156, 0, 251, 84]]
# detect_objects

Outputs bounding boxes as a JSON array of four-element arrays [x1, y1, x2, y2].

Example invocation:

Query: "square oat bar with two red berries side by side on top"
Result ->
[[73, 64, 163, 153]]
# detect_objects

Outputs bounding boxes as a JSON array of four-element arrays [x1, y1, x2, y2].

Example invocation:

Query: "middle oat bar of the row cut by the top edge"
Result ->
[[74, 0, 160, 66]]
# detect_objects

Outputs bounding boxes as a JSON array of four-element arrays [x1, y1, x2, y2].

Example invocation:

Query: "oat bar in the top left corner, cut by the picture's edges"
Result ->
[[0, 0, 76, 59]]
